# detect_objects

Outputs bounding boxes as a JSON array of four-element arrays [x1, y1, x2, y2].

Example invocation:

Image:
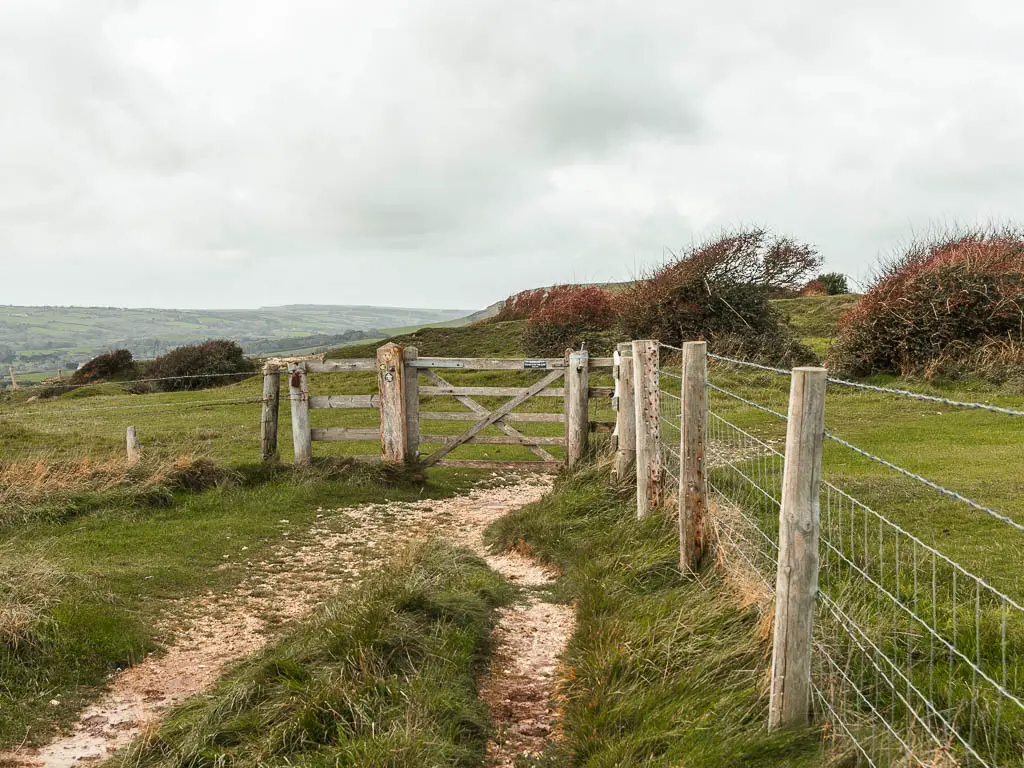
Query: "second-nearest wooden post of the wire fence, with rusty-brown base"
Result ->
[[679, 341, 708, 573]]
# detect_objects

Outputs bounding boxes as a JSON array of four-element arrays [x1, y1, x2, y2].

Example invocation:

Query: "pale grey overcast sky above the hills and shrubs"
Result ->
[[0, 0, 1024, 307]]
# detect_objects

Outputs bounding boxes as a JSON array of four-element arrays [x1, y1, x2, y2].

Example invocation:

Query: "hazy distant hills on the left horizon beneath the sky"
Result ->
[[0, 304, 473, 372]]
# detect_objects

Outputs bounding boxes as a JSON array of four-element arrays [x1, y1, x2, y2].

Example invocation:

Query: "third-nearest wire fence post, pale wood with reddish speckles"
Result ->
[[633, 339, 662, 518]]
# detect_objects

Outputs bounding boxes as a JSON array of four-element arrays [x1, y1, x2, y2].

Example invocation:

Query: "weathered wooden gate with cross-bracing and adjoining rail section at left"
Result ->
[[263, 344, 612, 472]]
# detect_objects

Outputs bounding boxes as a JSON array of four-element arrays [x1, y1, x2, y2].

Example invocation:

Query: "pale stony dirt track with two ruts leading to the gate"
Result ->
[[0, 477, 573, 768]]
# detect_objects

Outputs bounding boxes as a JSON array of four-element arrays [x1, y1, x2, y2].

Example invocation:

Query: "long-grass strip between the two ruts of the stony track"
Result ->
[[103, 542, 512, 768]]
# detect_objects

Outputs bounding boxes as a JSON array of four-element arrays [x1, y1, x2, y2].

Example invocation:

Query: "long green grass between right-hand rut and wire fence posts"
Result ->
[[488, 468, 822, 768]]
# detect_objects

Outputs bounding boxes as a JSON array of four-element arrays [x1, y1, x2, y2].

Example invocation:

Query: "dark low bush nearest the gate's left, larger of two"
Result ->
[[142, 339, 256, 392]]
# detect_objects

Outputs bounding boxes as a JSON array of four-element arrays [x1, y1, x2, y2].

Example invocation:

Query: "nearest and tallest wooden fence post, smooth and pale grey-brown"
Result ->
[[768, 368, 827, 729]]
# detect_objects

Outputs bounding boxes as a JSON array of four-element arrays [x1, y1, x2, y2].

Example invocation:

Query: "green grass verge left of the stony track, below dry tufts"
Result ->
[[0, 463, 481, 748]]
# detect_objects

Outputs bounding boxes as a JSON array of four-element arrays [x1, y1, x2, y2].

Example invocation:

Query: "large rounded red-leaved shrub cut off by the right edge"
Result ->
[[828, 229, 1024, 376]]
